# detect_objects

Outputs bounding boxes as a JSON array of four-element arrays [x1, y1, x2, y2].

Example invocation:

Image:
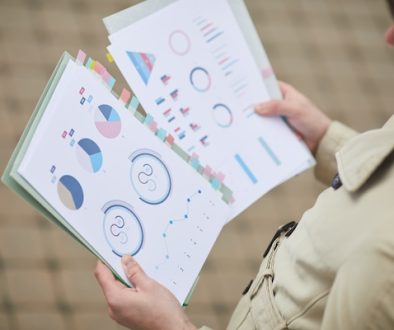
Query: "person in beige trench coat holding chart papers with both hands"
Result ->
[[95, 0, 394, 330]]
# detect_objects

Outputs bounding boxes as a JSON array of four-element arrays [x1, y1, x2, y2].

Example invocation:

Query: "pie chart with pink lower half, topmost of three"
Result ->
[[95, 104, 122, 139]]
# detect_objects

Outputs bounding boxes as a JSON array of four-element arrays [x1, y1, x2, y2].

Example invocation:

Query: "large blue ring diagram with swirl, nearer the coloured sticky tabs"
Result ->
[[129, 149, 172, 205]]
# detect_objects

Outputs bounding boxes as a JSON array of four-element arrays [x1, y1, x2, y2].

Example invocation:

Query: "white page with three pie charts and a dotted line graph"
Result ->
[[18, 61, 229, 303]]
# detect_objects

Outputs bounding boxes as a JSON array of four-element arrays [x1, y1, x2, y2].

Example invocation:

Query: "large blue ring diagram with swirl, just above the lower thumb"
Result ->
[[103, 201, 144, 257]]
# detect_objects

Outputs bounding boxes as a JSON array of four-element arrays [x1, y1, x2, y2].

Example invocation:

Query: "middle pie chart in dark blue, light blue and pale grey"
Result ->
[[77, 139, 103, 173]]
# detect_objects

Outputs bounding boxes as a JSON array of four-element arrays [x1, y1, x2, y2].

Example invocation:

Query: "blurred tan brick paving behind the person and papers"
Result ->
[[0, 0, 394, 330]]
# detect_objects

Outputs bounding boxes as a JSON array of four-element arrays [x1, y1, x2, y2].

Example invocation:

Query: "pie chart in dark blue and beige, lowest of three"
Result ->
[[57, 175, 83, 210]]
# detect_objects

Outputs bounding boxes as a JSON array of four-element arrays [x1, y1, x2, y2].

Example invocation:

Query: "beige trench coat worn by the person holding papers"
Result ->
[[205, 116, 394, 330]]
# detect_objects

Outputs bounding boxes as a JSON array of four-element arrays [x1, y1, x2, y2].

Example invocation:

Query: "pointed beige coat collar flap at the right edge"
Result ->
[[336, 115, 394, 192]]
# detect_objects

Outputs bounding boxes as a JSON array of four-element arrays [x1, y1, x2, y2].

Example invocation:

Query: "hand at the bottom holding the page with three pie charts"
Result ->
[[95, 256, 196, 330]]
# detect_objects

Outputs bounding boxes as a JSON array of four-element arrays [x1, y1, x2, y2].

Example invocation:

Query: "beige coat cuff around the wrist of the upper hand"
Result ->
[[315, 121, 357, 185]]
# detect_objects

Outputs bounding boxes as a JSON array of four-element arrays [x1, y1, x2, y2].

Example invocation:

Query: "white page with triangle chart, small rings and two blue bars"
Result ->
[[108, 0, 314, 218]]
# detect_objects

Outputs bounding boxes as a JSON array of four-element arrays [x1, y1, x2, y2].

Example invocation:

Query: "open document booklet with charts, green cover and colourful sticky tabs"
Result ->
[[2, 0, 314, 303]]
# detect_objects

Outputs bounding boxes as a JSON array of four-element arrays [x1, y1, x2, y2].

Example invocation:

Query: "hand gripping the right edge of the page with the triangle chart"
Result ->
[[255, 82, 331, 153]]
